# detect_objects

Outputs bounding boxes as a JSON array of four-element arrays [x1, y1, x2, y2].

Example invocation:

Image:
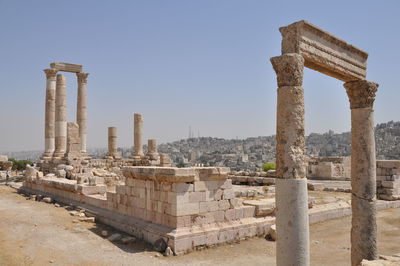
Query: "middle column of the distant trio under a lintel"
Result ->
[[54, 74, 67, 158]]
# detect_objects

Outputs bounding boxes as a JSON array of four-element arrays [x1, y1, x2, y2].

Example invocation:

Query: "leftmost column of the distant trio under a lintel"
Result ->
[[42, 68, 57, 159]]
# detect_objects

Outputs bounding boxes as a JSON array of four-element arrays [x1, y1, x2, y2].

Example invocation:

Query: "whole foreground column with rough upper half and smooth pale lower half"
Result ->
[[271, 53, 310, 266]]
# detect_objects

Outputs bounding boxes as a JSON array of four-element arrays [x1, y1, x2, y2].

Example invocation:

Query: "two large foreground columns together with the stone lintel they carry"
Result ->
[[271, 21, 378, 265]]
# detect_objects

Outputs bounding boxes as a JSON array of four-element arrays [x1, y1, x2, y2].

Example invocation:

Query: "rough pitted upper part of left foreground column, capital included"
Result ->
[[271, 54, 306, 178]]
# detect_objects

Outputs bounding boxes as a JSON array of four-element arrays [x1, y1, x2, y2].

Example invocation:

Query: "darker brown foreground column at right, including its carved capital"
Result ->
[[344, 80, 378, 265]]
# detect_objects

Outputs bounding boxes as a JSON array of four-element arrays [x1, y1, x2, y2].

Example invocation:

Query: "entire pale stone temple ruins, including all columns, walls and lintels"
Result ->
[[14, 21, 400, 266]]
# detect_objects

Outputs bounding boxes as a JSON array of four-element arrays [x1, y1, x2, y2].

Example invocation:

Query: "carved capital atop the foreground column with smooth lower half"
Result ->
[[270, 53, 304, 87]]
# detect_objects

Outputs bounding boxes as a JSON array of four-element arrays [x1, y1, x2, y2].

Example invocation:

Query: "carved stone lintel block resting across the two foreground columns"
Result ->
[[279, 20, 368, 82]]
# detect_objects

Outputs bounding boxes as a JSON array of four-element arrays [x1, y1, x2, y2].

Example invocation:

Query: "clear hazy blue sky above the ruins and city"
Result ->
[[0, 0, 400, 152]]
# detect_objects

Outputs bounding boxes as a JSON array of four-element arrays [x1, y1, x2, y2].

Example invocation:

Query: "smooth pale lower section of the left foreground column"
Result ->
[[275, 178, 310, 266]]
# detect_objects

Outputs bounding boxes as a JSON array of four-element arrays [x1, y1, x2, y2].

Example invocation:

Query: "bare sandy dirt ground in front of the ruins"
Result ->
[[0, 184, 400, 266]]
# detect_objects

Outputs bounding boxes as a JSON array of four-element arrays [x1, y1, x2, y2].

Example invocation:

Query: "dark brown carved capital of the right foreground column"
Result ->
[[343, 80, 379, 109]]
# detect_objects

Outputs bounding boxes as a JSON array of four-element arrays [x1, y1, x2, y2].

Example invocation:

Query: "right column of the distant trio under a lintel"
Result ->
[[76, 72, 89, 155]]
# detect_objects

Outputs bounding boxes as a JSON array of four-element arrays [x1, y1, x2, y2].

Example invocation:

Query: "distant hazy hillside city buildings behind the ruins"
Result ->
[[0, 121, 400, 171]]
